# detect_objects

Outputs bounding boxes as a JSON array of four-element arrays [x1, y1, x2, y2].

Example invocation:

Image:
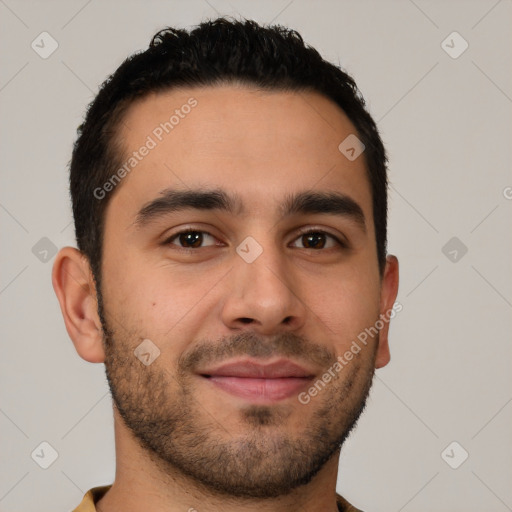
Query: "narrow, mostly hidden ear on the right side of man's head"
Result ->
[[375, 256, 398, 368]]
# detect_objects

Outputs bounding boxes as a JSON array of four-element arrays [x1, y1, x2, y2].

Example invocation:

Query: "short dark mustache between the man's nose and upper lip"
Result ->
[[178, 331, 336, 373]]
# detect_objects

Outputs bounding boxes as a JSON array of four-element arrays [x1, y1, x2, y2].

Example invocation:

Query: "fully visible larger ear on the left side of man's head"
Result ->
[[52, 247, 105, 363]]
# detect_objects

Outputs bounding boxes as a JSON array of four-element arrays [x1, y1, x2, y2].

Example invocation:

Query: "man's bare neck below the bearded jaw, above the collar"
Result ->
[[96, 407, 339, 512]]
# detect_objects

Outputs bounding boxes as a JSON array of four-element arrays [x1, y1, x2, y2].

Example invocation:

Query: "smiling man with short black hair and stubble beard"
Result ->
[[53, 18, 398, 512]]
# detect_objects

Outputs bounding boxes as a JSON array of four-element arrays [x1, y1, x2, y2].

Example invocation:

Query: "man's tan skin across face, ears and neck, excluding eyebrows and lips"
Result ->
[[53, 85, 398, 512]]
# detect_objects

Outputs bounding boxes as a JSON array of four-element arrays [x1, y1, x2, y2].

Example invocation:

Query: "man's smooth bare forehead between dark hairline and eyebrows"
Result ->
[[109, 85, 371, 225]]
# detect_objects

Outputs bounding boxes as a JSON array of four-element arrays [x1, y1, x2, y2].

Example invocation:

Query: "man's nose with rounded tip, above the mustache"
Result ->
[[222, 241, 308, 335]]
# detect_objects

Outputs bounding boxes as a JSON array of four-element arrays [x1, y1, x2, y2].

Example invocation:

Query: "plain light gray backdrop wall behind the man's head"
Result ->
[[0, 0, 512, 512]]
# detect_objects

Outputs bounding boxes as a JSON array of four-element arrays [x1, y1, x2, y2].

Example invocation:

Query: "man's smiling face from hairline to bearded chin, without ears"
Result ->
[[101, 86, 394, 497]]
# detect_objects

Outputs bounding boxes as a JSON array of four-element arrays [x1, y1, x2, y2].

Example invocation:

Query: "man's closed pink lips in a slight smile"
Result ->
[[199, 359, 314, 404]]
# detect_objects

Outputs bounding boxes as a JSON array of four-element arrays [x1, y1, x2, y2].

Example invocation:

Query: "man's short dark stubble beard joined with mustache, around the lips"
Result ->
[[100, 306, 378, 499]]
